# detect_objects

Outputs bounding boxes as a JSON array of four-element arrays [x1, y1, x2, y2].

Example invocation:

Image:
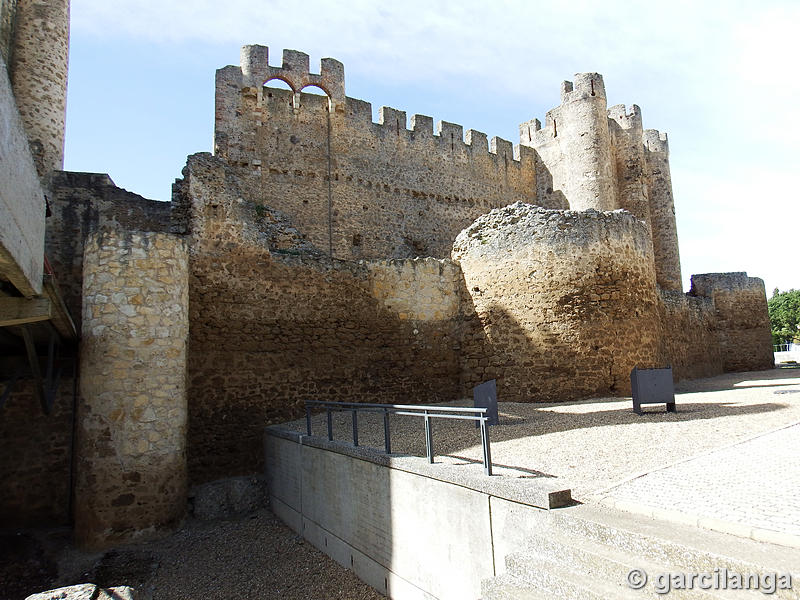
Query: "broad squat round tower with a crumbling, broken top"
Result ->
[[453, 203, 661, 402]]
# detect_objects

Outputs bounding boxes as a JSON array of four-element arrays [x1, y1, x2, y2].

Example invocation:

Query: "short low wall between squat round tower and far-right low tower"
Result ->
[[659, 289, 723, 381]]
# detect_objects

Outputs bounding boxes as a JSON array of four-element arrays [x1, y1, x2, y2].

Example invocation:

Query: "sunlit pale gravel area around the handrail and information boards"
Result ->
[[287, 368, 800, 499]]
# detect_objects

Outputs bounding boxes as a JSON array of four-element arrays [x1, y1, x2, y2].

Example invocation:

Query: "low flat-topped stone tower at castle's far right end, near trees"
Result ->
[[689, 272, 775, 371]]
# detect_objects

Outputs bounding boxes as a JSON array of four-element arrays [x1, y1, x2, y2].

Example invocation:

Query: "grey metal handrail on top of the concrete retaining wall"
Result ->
[[306, 400, 492, 475]]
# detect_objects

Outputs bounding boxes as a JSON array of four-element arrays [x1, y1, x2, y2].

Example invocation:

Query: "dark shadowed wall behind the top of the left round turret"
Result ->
[[45, 171, 171, 330]]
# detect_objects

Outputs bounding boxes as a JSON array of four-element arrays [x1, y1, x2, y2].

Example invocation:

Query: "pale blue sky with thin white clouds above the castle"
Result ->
[[65, 0, 800, 295]]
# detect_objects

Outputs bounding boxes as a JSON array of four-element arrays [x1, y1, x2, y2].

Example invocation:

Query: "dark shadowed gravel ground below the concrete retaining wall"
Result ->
[[0, 508, 383, 600]]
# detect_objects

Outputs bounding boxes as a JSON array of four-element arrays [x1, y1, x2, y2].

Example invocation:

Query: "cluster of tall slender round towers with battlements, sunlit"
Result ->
[[520, 73, 682, 291]]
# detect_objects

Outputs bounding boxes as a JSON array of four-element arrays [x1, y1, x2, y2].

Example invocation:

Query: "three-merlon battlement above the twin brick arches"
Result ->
[[240, 44, 345, 103]]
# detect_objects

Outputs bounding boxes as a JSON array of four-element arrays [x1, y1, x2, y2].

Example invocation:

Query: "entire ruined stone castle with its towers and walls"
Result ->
[[0, 0, 773, 547]]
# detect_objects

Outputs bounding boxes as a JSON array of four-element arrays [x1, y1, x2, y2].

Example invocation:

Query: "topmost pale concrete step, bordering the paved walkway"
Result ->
[[524, 505, 800, 600]]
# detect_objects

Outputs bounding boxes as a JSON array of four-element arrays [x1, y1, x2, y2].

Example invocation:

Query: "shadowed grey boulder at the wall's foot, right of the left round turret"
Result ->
[[189, 477, 268, 521]]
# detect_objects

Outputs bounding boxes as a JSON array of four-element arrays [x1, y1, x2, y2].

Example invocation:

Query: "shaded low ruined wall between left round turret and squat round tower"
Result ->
[[175, 155, 463, 483]]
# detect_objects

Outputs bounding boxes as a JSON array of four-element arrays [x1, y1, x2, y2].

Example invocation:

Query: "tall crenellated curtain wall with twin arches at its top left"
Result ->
[[215, 46, 536, 259]]
